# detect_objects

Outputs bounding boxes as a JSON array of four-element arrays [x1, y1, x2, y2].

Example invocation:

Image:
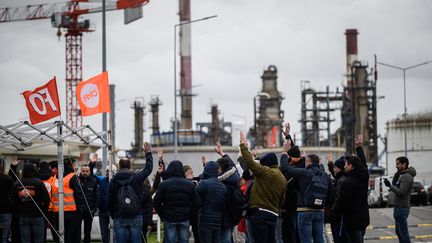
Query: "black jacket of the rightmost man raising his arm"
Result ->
[[332, 154, 369, 230]]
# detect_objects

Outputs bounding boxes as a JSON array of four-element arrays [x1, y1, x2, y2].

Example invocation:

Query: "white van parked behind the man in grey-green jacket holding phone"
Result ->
[[368, 176, 392, 208]]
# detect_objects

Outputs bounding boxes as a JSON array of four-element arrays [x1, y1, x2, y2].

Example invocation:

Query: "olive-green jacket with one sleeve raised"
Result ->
[[240, 144, 286, 213]]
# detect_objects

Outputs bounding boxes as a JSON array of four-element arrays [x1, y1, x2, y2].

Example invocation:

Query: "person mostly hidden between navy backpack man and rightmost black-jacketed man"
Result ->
[[326, 154, 348, 243]]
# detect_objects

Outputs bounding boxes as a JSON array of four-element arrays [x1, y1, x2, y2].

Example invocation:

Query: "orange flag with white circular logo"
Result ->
[[77, 72, 111, 116]]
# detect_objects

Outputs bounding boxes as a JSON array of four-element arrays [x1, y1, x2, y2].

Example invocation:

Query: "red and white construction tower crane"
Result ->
[[0, 0, 149, 127]]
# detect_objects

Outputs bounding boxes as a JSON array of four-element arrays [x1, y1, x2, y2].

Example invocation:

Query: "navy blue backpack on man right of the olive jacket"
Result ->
[[303, 170, 329, 209]]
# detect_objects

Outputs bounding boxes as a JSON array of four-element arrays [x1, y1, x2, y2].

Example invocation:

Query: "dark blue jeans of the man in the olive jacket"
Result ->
[[251, 210, 278, 243]]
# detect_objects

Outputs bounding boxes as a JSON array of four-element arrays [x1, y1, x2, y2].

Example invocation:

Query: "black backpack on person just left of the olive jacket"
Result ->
[[224, 187, 248, 227]]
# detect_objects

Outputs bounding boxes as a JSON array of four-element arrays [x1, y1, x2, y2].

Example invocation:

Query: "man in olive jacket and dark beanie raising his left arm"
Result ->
[[240, 132, 287, 242]]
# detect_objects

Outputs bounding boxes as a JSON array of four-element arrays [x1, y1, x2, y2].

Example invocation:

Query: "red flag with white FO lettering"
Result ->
[[22, 77, 61, 124]]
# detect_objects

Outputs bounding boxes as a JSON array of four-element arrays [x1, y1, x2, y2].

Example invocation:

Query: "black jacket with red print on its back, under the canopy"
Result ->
[[12, 178, 50, 217]]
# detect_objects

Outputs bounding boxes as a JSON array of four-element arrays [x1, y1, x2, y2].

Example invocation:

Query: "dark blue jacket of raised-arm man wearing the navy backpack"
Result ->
[[280, 154, 334, 207]]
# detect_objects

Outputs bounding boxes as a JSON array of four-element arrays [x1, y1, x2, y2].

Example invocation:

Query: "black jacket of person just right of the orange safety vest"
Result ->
[[79, 176, 100, 213]]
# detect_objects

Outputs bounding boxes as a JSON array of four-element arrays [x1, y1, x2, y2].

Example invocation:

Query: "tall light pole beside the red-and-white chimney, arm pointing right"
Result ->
[[174, 15, 217, 159]]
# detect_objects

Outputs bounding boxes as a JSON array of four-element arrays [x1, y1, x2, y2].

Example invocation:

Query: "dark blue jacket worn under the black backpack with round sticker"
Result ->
[[108, 152, 153, 218]]
